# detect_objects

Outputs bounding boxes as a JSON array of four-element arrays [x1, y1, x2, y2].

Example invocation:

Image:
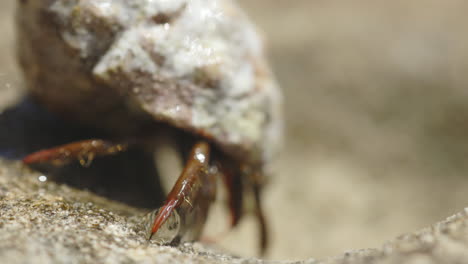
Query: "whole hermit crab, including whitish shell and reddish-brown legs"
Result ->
[[17, 0, 282, 253]]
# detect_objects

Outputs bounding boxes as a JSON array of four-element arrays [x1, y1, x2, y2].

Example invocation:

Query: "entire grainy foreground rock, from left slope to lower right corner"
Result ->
[[0, 160, 468, 264]]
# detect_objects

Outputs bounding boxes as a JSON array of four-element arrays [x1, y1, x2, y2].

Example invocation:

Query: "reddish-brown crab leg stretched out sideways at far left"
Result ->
[[23, 139, 128, 166]]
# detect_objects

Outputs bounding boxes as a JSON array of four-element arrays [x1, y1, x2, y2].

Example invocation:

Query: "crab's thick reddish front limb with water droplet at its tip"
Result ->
[[148, 142, 216, 243]]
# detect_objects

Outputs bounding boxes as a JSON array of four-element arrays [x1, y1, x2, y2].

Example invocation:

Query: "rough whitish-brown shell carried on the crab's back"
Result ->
[[17, 0, 282, 163]]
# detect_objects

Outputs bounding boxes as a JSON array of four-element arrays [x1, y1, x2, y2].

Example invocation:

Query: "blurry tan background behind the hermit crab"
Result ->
[[0, 0, 468, 259]]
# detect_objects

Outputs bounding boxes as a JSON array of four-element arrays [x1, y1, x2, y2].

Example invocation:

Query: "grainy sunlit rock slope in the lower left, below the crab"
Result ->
[[0, 161, 247, 263]]
